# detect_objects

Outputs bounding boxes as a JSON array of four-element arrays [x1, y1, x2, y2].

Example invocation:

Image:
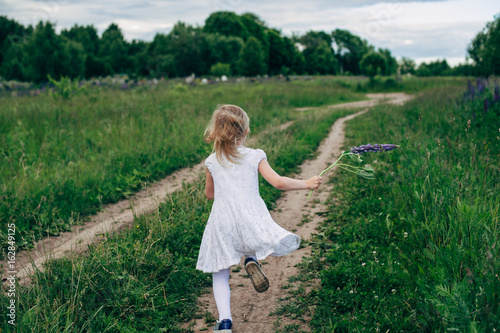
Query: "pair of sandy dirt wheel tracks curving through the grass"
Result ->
[[1, 93, 410, 292]]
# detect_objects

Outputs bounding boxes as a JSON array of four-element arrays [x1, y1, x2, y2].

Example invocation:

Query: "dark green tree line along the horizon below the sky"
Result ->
[[0, 11, 499, 82]]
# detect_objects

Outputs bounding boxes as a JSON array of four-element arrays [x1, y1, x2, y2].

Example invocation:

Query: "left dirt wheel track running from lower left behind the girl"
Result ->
[[0, 93, 409, 283]]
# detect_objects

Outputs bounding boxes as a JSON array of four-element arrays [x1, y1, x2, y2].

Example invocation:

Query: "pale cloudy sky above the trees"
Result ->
[[0, 0, 500, 65]]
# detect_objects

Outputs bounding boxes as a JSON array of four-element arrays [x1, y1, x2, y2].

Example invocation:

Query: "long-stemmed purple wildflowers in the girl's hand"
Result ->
[[307, 143, 399, 199]]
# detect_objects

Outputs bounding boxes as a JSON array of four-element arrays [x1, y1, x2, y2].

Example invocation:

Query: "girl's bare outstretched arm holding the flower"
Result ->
[[259, 159, 323, 191]]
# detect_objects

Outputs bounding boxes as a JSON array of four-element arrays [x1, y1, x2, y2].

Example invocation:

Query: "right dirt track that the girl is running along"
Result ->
[[185, 93, 411, 333]]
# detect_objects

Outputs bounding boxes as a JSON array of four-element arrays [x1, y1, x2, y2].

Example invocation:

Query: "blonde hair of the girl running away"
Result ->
[[204, 104, 250, 165]]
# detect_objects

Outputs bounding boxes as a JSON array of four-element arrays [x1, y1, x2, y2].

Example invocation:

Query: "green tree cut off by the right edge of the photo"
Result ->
[[467, 14, 500, 76]]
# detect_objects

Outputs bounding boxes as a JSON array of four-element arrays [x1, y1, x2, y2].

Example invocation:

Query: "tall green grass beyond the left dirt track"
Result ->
[[0, 81, 360, 254]]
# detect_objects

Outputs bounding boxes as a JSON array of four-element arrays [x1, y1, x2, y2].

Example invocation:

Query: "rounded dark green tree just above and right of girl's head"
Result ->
[[239, 36, 267, 76]]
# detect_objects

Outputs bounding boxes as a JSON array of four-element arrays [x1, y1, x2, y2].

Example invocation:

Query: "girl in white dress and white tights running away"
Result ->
[[196, 105, 322, 332]]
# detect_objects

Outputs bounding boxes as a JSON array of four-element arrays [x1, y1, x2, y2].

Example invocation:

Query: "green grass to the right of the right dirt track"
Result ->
[[279, 78, 500, 332]]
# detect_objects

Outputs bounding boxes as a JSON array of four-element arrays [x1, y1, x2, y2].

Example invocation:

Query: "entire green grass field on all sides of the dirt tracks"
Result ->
[[0, 77, 490, 332]]
